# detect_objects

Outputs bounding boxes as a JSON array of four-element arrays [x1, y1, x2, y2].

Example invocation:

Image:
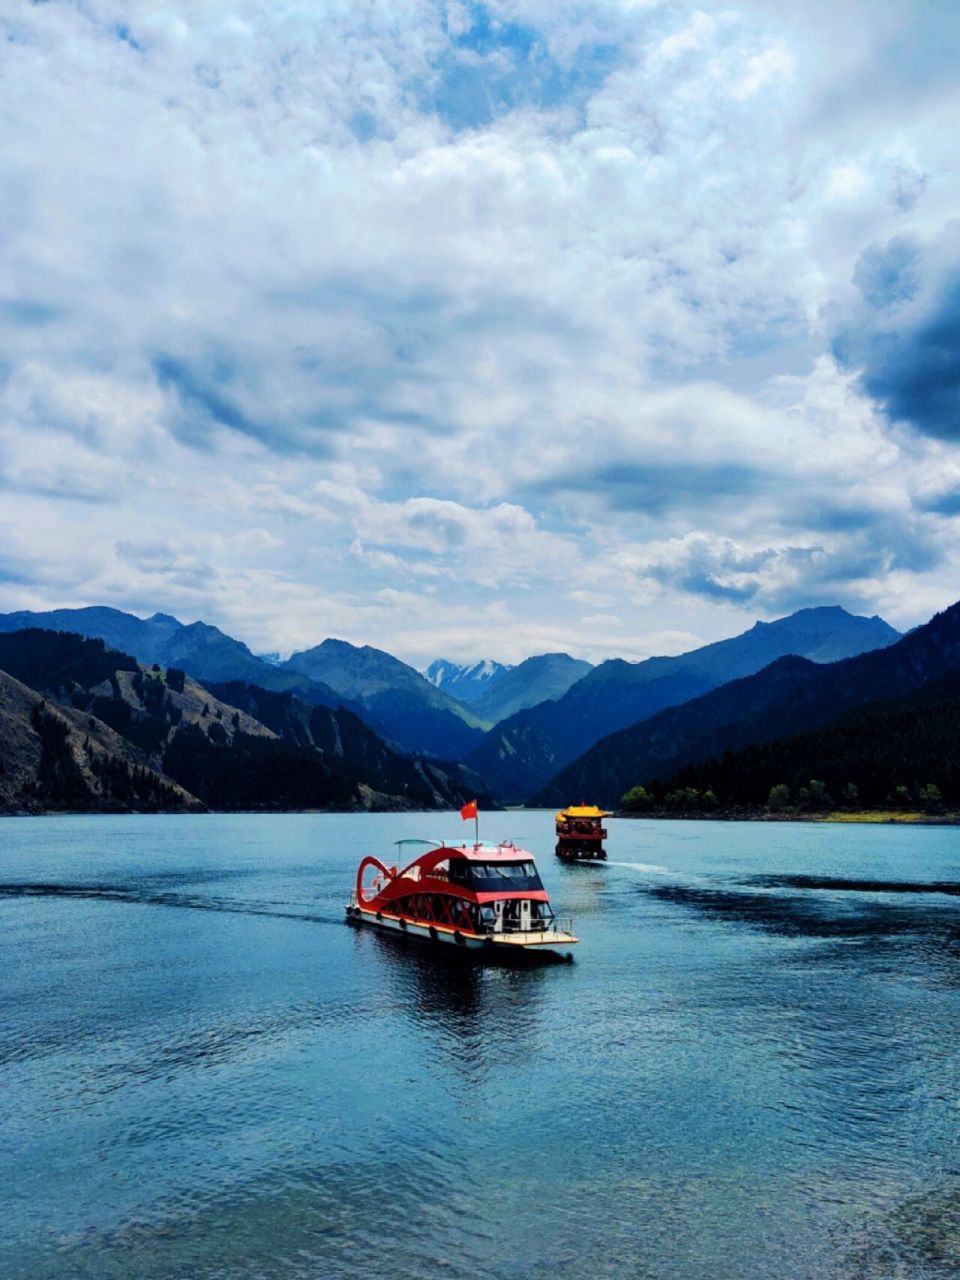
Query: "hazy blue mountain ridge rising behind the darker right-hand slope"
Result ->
[[466, 607, 899, 804]]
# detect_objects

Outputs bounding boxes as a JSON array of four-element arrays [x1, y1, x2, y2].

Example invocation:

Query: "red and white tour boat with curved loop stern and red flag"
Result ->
[[347, 839, 577, 955]]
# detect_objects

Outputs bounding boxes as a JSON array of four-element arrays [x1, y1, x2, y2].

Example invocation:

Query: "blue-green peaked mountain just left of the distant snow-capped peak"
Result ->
[[283, 640, 488, 759]]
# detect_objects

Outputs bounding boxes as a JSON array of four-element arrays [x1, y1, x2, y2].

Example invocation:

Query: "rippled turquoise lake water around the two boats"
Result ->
[[0, 813, 960, 1280]]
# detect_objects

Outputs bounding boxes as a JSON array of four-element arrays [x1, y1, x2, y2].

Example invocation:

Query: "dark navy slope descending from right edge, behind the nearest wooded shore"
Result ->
[[531, 604, 960, 804]]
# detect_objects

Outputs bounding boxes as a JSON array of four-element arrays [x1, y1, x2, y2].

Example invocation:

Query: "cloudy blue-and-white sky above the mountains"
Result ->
[[0, 0, 960, 667]]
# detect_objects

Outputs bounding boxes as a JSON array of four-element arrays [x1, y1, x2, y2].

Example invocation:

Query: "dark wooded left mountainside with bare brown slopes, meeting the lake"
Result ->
[[0, 630, 492, 813]]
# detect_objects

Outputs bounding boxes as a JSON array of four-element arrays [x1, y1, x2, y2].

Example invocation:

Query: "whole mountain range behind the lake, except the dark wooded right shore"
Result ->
[[0, 607, 942, 812]]
